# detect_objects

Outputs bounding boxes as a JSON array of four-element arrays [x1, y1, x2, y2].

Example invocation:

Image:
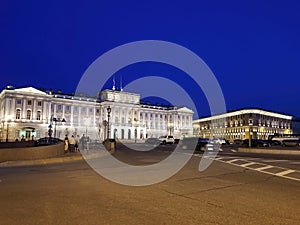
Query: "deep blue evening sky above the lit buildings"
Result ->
[[0, 0, 300, 116]]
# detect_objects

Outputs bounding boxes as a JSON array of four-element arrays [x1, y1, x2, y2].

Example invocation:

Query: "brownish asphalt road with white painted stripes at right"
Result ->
[[0, 143, 300, 225]]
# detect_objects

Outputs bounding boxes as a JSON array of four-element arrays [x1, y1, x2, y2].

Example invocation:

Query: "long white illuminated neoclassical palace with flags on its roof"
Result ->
[[0, 86, 193, 141]]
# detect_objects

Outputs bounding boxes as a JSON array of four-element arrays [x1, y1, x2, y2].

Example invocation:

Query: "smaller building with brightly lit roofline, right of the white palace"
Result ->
[[193, 109, 293, 141]]
